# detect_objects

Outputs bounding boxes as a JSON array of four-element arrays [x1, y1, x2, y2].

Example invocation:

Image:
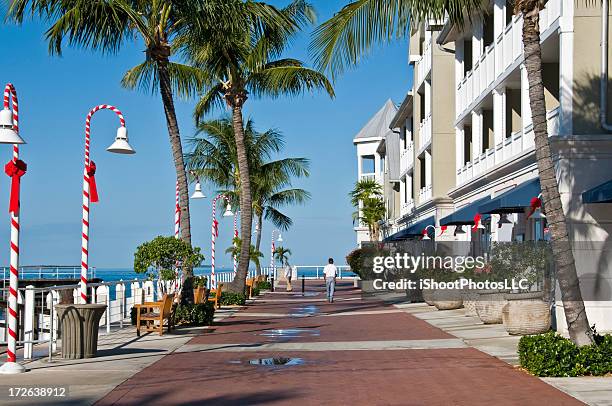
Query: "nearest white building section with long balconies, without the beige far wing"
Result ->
[[438, 0, 612, 329]]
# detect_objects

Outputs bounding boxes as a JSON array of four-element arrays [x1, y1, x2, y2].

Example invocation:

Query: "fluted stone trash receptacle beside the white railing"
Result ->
[[55, 304, 106, 359]]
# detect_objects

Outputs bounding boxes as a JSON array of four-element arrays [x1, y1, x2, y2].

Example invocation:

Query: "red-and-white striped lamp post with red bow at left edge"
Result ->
[[0, 83, 26, 374]]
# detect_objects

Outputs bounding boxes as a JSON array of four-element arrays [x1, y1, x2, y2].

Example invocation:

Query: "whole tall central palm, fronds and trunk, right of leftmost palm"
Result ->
[[183, 0, 334, 292]]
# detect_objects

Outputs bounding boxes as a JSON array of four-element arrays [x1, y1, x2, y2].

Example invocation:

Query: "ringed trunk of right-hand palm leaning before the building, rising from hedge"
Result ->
[[519, 5, 592, 346]]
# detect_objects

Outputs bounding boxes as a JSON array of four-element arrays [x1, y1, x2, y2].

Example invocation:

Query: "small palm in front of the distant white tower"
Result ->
[[349, 179, 387, 241]]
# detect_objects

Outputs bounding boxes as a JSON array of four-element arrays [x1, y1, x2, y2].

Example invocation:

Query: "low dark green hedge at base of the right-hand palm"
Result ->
[[518, 331, 612, 376]]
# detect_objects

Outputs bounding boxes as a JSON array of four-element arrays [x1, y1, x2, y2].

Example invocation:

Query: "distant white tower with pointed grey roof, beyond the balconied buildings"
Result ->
[[353, 100, 399, 245]]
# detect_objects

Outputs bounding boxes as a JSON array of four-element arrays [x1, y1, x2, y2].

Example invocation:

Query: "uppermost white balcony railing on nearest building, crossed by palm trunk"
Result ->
[[455, 0, 561, 117]]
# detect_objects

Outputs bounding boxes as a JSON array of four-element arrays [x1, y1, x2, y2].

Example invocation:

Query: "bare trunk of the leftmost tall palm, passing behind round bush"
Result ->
[[157, 60, 193, 301]]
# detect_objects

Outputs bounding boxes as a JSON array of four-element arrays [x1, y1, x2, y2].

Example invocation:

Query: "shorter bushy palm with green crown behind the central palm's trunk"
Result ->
[[185, 118, 310, 275]]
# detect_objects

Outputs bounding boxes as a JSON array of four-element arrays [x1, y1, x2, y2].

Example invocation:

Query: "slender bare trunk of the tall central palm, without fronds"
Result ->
[[229, 102, 253, 293]]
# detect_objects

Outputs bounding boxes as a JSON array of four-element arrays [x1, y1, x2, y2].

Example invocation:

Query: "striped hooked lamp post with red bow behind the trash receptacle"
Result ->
[[80, 104, 136, 303]]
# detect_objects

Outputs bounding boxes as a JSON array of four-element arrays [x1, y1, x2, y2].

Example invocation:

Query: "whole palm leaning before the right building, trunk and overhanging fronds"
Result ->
[[311, 0, 592, 346]]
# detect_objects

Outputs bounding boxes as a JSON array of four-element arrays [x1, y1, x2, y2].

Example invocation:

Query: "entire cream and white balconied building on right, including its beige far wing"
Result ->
[[358, 0, 612, 330]]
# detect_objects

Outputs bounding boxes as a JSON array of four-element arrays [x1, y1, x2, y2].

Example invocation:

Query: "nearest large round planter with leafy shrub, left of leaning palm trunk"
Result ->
[[502, 241, 552, 335]]
